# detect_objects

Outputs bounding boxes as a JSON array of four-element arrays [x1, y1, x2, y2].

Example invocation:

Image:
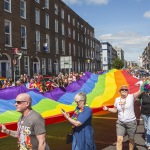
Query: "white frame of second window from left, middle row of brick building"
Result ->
[[21, 25, 27, 49]]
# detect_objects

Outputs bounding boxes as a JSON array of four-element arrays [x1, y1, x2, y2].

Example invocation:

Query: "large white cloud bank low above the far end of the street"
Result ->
[[99, 31, 150, 61]]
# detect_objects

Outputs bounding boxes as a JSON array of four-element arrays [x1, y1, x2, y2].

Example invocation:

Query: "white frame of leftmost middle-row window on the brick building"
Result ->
[[4, 20, 12, 46]]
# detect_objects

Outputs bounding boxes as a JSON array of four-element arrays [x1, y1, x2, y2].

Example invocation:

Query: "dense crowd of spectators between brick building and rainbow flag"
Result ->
[[0, 72, 88, 93]]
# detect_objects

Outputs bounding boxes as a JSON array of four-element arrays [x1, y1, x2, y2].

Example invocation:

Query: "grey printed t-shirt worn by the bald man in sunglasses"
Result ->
[[17, 110, 46, 150]]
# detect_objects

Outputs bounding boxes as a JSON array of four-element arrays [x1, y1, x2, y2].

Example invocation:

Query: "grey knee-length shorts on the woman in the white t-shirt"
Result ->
[[116, 120, 137, 139]]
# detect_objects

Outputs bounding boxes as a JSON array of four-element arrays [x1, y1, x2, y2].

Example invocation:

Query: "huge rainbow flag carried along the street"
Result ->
[[0, 69, 139, 137]]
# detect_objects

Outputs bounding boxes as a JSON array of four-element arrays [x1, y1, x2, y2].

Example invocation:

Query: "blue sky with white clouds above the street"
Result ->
[[62, 0, 150, 62]]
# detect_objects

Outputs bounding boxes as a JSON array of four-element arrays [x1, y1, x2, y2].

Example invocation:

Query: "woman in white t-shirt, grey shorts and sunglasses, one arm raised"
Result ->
[[103, 85, 142, 150]]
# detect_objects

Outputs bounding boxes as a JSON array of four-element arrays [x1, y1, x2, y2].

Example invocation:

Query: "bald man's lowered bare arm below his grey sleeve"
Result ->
[[36, 133, 46, 150]]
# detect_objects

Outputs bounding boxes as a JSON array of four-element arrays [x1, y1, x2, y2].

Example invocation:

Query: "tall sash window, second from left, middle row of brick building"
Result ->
[[21, 26, 27, 48]]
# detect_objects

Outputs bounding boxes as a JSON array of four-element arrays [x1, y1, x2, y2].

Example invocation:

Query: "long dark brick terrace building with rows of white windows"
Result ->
[[0, 0, 95, 77]]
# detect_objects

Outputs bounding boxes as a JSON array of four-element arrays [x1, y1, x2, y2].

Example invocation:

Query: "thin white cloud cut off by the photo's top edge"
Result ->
[[63, 0, 109, 5]]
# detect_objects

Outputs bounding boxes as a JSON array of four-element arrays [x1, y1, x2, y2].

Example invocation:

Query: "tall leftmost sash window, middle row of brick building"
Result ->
[[4, 20, 12, 46]]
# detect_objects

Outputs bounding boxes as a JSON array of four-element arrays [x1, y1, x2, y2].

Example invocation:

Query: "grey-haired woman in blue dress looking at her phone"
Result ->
[[62, 92, 96, 150]]
